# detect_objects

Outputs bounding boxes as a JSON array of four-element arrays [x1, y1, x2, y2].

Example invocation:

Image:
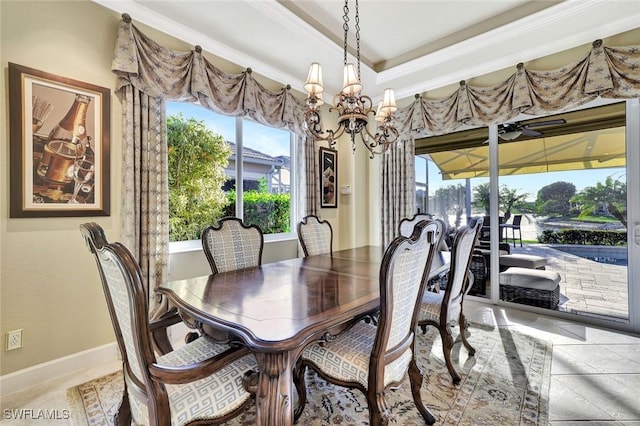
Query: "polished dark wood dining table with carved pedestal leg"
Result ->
[[158, 246, 384, 426]]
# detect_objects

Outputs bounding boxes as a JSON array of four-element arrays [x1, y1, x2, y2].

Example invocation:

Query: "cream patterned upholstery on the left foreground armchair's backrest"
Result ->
[[97, 251, 145, 381]]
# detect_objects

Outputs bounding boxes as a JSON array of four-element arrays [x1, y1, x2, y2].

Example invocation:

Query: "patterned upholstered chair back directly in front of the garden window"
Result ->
[[202, 218, 264, 273]]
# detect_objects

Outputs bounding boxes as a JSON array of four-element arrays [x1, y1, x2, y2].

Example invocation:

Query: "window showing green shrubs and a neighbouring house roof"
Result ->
[[167, 102, 296, 241]]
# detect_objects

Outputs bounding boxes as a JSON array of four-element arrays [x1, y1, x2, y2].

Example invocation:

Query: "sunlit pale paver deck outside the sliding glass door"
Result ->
[[511, 243, 629, 320]]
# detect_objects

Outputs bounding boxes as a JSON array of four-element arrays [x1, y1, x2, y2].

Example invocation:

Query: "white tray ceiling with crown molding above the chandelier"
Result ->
[[94, 0, 640, 105]]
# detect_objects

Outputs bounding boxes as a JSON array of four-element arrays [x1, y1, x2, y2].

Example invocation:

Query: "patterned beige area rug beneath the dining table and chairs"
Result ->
[[68, 324, 552, 426]]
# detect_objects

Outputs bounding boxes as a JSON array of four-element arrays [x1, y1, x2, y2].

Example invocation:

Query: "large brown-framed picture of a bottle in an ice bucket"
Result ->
[[8, 63, 111, 218]]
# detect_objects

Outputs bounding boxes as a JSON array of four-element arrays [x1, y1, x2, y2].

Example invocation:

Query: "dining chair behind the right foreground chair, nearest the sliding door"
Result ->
[[418, 218, 483, 383]]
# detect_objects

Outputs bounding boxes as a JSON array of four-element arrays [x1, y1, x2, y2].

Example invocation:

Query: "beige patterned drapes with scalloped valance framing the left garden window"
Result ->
[[111, 14, 319, 318]]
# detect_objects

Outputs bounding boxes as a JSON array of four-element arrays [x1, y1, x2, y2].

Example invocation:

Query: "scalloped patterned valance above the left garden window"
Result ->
[[111, 14, 306, 134]]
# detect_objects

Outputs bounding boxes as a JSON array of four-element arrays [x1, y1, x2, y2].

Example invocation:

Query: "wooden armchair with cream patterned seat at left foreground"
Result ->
[[80, 223, 257, 425]]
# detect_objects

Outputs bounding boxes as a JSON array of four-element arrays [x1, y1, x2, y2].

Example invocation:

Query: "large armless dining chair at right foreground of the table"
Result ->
[[294, 221, 442, 425]]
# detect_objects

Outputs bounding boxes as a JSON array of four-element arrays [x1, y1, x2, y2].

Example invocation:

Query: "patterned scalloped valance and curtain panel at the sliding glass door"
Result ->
[[382, 40, 640, 241]]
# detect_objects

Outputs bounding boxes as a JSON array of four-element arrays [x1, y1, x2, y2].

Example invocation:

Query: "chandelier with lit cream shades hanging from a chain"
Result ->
[[304, 0, 400, 158]]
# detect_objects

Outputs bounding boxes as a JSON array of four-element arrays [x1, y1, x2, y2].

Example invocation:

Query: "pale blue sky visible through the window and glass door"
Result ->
[[167, 102, 626, 201]]
